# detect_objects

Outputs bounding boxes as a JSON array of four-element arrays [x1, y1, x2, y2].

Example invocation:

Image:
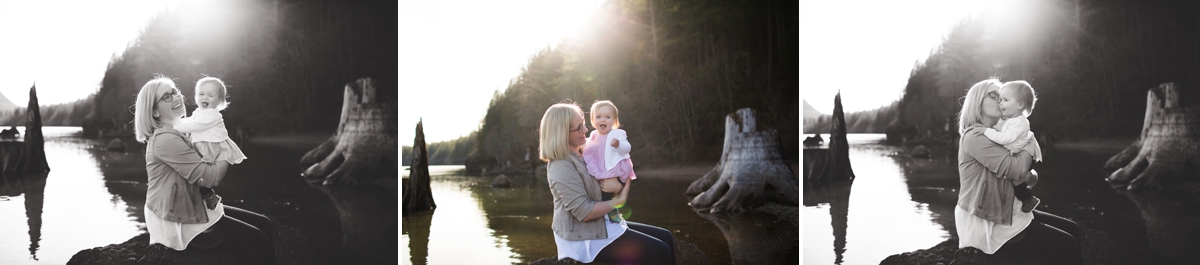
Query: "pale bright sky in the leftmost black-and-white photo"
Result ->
[[0, 0, 178, 107]]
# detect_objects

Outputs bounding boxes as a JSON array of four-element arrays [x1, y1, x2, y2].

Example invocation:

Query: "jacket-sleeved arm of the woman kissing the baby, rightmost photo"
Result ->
[[962, 127, 1033, 183]]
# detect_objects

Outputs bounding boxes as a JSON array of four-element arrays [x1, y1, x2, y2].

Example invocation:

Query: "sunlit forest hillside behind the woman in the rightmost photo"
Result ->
[[897, 0, 1200, 137]]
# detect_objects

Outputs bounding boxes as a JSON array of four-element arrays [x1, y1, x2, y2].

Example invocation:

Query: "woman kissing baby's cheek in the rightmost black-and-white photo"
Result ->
[[954, 79, 1082, 264]]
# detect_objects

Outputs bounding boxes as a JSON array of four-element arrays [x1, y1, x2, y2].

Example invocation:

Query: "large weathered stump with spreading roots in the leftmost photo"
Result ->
[[300, 78, 400, 186]]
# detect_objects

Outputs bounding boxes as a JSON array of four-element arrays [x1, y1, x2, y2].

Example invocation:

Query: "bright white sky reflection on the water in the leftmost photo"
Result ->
[[0, 127, 144, 264]]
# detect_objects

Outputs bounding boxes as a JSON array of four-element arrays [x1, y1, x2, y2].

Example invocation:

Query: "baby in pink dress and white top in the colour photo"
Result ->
[[583, 101, 637, 223]]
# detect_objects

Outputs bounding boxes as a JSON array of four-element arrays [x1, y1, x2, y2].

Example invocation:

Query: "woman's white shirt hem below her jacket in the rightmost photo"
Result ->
[[954, 197, 1033, 254]]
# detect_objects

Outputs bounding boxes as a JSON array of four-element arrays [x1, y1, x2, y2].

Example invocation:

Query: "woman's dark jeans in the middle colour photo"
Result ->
[[595, 221, 676, 264]]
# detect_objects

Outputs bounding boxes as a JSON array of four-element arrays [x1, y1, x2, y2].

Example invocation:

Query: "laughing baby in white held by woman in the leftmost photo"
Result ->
[[175, 77, 246, 209]]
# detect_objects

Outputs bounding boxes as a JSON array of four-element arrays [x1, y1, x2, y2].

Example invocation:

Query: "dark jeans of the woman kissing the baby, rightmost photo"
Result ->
[[997, 210, 1084, 264]]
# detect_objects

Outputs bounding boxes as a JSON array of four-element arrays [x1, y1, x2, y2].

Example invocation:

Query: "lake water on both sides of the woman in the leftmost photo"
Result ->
[[0, 127, 398, 264]]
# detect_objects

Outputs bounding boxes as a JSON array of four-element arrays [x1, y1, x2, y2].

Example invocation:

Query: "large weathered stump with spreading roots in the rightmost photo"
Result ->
[[1104, 83, 1200, 189]]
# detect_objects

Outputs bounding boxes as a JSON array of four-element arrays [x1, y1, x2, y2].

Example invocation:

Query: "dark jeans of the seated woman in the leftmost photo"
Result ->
[[214, 205, 275, 264]]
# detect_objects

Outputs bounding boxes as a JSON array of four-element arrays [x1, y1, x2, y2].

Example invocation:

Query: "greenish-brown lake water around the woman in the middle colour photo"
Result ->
[[400, 165, 799, 264]]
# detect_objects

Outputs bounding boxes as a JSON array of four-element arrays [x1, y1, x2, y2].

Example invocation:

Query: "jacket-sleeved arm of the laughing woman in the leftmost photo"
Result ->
[[150, 133, 229, 187]]
